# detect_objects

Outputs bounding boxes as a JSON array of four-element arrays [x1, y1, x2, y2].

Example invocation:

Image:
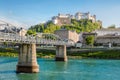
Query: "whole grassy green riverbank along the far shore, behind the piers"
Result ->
[[0, 48, 120, 59]]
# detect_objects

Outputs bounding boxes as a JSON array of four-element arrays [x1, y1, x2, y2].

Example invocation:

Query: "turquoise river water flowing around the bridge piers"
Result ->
[[0, 57, 120, 80]]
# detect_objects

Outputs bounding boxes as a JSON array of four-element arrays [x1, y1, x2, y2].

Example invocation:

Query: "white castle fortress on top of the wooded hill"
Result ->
[[52, 12, 96, 25]]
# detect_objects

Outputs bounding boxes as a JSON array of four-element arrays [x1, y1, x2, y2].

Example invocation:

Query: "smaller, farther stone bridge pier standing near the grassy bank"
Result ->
[[55, 45, 67, 61]]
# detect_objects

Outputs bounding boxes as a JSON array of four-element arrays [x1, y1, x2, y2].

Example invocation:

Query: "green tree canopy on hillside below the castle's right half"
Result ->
[[62, 19, 101, 33]]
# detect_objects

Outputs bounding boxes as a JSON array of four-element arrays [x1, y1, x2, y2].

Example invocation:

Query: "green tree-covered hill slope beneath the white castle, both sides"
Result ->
[[29, 19, 101, 33]]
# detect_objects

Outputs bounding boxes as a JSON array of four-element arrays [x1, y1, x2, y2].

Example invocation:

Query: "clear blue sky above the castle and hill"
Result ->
[[0, 0, 120, 28]]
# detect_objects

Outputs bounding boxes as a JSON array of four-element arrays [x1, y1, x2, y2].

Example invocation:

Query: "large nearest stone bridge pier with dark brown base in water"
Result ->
[[17, 44, 39, 73]]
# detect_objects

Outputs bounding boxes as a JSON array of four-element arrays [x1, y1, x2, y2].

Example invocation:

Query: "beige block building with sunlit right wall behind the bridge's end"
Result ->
[[54, 29, 79, 43]]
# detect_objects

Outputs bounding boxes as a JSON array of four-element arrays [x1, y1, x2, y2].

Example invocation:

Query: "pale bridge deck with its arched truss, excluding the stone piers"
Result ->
[[0, 32, 74, 46]]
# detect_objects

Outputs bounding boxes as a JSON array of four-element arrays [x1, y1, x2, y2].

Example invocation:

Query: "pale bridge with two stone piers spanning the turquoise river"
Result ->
[[0, 32, 74, 73]]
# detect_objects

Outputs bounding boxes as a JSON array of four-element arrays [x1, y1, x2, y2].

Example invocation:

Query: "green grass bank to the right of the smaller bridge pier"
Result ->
[[68, 50, 120, 59]]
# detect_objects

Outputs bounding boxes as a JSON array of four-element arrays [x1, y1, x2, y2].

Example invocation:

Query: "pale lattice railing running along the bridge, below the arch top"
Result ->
[[0, 32, 73, 45]]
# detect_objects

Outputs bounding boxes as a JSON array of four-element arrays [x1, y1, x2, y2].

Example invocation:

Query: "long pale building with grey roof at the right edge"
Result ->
[[94, 29, 120, 47]]
